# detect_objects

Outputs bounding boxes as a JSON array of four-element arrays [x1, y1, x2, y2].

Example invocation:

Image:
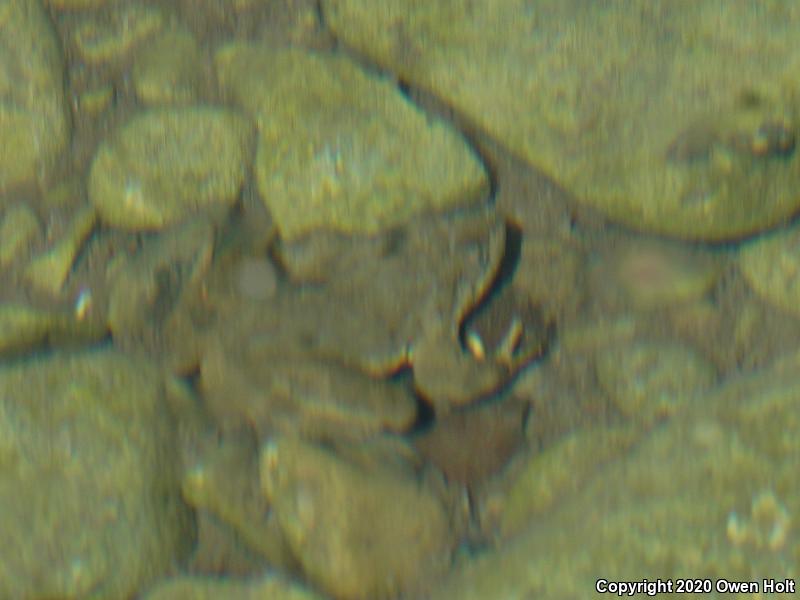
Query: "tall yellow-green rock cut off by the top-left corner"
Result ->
[[0, 0, 69, 191]]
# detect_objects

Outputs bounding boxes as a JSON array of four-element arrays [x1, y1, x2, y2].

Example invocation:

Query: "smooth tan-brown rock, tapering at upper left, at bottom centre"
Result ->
[[261, 438, 453, 600]]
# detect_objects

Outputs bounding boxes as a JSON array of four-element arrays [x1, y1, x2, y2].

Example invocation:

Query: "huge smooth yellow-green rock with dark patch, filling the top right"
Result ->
[[322, 0, 800, 240]]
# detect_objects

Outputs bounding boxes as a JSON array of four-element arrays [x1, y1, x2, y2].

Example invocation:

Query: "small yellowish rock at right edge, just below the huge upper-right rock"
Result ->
[[738, 227, 800, 316]]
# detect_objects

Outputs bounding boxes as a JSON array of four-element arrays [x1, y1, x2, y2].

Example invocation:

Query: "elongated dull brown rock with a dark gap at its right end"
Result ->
[[200, 338, 417, 440]]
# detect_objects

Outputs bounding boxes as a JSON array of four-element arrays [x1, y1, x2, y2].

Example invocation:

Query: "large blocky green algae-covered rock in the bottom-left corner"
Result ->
[[0, 350, 191, 599]]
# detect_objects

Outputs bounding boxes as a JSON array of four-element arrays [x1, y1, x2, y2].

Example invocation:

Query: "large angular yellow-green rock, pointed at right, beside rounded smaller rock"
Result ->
[[216, 44, 488, 239]]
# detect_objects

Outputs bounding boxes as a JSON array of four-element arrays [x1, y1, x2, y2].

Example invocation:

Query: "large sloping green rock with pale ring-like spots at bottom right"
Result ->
[[432, 359, 800, 600]]
